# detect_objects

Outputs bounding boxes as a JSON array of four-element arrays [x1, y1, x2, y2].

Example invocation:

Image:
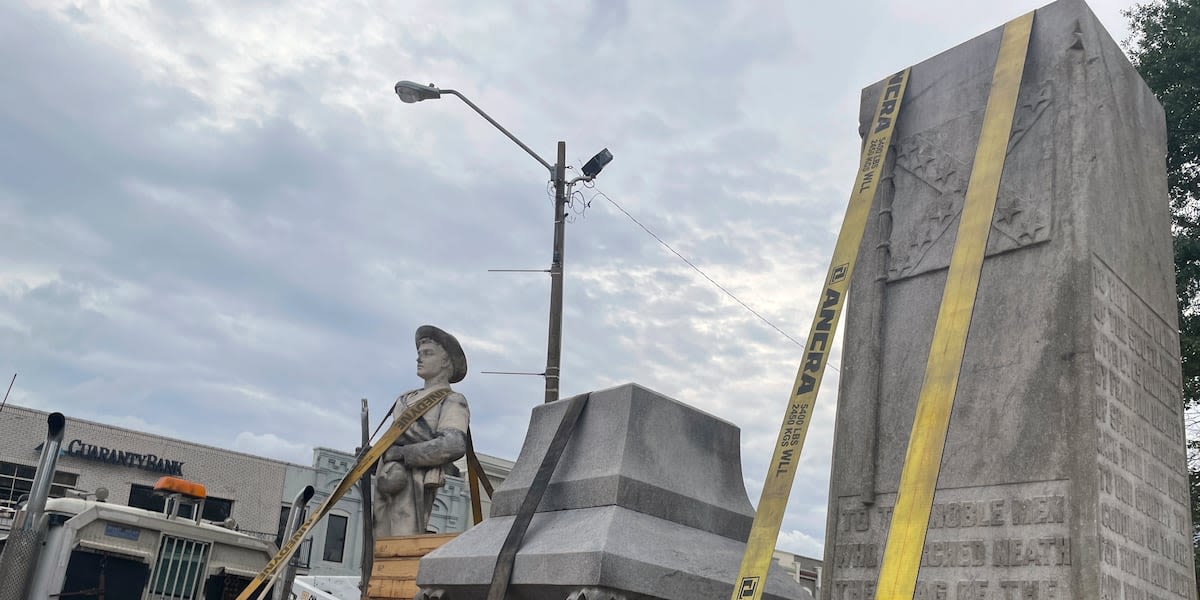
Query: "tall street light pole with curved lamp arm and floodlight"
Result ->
[[396, 82, 612, 402]]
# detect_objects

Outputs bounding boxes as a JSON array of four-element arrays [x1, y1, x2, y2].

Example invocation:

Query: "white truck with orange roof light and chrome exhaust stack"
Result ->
[[0, 413, 276, 600]]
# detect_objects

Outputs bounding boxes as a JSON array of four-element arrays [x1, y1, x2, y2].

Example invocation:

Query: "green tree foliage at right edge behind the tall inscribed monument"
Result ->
[[1124, 0, 1200, 580]]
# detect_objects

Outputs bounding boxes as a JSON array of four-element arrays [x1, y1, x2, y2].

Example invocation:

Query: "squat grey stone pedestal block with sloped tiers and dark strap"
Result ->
[[418, 384, 810, 600]]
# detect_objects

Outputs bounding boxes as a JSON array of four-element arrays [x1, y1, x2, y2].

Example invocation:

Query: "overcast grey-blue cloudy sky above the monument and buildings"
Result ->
[[0, 0, 1133, 557]]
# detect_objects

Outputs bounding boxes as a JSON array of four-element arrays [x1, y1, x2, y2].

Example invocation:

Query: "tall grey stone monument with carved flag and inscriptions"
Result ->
[[821, 0, 1196, 600]]
